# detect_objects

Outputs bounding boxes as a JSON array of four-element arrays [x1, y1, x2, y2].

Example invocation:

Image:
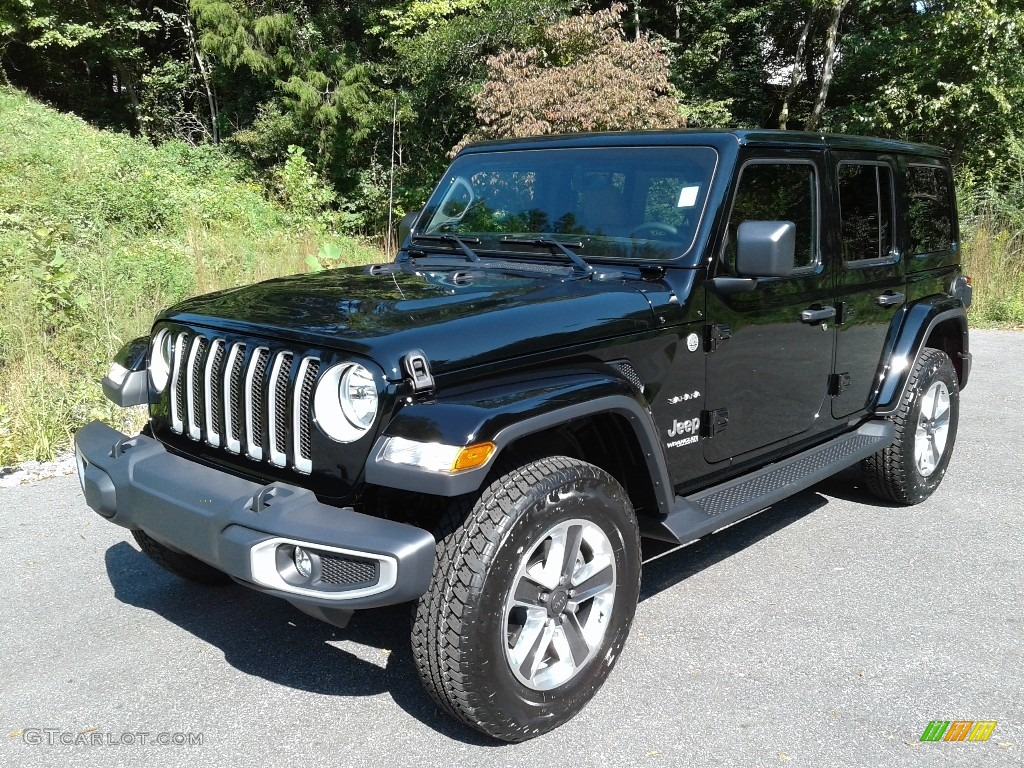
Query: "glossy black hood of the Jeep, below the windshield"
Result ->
[[161, 263, 654, 379]]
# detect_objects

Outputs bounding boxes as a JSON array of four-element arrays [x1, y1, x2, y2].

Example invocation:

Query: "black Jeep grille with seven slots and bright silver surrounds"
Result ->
[[169, 331, 321, 473]]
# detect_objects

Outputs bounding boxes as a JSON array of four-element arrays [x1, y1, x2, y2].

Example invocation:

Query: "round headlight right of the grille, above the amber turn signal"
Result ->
[[313, 362, 377, 442]]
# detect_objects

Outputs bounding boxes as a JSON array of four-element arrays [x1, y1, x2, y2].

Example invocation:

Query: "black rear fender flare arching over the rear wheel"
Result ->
[[874, 297, 971, 416]]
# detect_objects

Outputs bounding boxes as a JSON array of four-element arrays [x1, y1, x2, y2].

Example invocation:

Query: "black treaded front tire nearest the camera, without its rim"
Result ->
[[413, 457, 640, 741]]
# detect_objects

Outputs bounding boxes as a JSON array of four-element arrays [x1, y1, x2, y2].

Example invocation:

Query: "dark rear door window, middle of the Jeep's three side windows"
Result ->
[[839, 163, 895, 263]]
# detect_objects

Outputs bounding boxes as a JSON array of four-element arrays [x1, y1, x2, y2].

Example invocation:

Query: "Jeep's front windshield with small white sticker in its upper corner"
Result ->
[[417, 146, 718, 260]]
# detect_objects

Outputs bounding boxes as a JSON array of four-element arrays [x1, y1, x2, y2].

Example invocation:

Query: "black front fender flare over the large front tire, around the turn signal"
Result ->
[[365, 371, 674, 513]]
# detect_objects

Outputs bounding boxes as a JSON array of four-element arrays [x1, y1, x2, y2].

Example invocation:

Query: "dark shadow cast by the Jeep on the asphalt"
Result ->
[[105, 481, 843, 746]]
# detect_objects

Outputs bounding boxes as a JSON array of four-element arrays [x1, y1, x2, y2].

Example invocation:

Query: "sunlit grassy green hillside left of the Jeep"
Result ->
[[0, 87, 383, 466]]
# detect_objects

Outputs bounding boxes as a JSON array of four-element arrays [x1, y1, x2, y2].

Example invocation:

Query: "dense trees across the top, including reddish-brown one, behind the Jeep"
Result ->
[[8, 0, 1024, 227]]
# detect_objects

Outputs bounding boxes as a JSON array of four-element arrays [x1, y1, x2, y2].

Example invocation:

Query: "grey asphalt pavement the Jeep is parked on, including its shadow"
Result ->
[[0, 332, 1024, 768]]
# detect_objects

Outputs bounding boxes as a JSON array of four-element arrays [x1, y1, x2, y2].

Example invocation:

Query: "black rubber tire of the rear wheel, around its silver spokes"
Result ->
[[861, 348, 959, 505]]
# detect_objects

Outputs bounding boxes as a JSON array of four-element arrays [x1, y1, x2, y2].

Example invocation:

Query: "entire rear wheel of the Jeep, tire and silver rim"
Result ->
[[861, 348, 959, 504]]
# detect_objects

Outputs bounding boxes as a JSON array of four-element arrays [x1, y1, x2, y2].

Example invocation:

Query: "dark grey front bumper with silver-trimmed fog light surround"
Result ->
[[75, 422, 435, 621]]
